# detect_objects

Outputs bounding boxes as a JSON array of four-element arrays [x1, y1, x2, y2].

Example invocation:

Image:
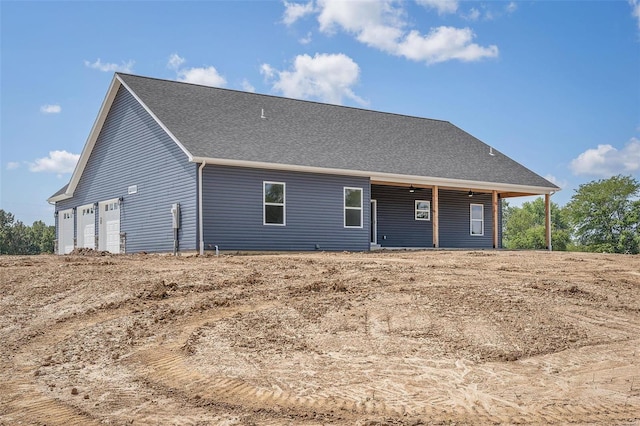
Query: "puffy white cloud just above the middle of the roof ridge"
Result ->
[[260, 53, 366, 105]]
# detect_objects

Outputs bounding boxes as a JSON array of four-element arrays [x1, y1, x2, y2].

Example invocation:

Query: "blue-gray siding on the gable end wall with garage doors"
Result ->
[[56, 87, 197, 253]]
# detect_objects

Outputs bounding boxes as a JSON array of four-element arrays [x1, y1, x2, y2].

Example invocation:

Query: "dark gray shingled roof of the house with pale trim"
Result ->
[[51, 73, 559, 202]]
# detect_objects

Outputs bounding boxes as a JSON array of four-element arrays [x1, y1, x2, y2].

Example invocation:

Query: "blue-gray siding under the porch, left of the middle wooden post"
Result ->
[[371, 185, 433, 247]]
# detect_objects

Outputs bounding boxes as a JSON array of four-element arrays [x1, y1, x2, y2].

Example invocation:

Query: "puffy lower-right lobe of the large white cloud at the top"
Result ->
[[398, 27, 498, 64]]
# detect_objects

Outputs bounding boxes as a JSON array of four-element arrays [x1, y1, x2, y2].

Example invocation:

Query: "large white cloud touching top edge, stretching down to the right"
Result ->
[[318, 0, 498, 64]]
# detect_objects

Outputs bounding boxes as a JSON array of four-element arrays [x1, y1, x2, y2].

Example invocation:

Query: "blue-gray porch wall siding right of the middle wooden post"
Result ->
[[438, 189, 500, 248]]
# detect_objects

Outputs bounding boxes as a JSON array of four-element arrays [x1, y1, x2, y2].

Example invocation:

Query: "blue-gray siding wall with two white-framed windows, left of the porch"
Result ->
[[203, 166, 370, 251]]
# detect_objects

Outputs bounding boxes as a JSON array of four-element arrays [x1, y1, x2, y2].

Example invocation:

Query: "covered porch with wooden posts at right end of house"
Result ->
[[370, 180, 553, 250]]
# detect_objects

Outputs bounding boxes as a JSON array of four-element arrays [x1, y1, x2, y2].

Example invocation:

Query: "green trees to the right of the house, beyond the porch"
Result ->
[[503, 176, 640, 254]]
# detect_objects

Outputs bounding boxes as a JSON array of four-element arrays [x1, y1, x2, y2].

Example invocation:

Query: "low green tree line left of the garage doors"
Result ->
[[0, 209, 56, 254]]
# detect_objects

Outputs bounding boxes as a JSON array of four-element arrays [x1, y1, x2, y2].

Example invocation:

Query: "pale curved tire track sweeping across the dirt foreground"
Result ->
[[128, 306, 640, 423]]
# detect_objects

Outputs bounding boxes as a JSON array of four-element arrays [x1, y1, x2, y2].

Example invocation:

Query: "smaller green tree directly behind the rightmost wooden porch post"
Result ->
[[503, 198, 571, 250]]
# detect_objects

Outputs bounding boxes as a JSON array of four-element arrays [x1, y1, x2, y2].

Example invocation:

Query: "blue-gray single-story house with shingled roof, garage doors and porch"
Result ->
[[49, 73, 559, 254]]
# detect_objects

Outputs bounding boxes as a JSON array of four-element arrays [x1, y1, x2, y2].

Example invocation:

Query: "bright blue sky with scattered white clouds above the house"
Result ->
[[0, 0, 640, 224]]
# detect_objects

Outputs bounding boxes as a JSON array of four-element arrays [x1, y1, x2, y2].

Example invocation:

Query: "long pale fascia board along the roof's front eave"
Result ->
[[191, 157, 560, 195]]
